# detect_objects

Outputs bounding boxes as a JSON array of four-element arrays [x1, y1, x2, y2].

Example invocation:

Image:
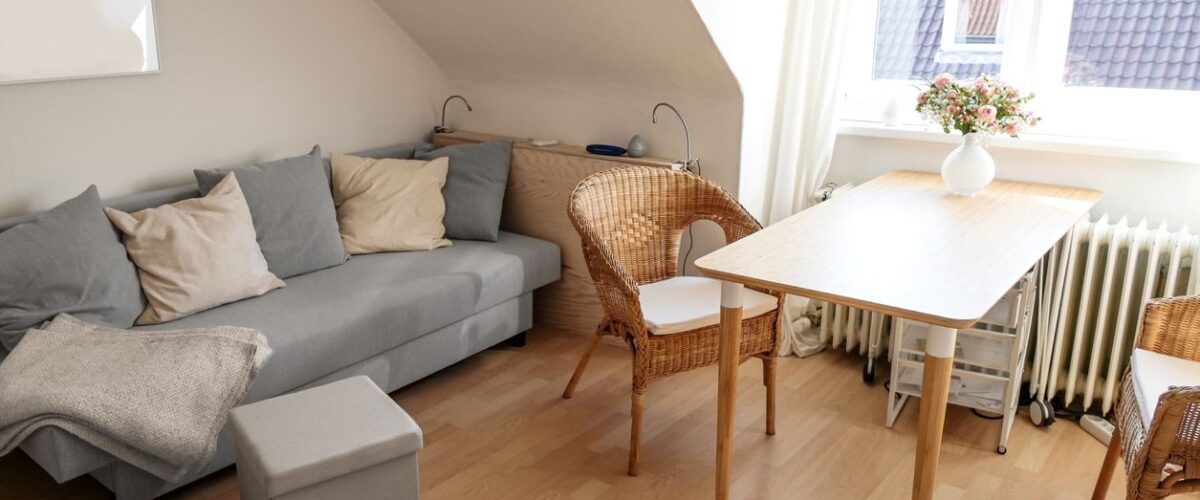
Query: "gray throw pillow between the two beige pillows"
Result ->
[[196, 146, 349, 278]]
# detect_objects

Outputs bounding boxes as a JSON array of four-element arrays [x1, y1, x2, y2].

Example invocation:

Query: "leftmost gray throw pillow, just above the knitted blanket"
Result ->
[[0, 186, 145, 350]]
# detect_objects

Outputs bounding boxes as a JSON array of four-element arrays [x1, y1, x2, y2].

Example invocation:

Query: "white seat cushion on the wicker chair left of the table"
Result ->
[[638, 276, 779, 335]]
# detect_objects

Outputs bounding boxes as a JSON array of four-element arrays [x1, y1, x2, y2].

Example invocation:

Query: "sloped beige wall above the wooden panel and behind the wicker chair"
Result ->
[[377, 0, 742, 267]]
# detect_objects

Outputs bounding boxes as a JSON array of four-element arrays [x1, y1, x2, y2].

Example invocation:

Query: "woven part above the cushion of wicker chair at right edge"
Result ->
[[1138, 296, 1200, 361]]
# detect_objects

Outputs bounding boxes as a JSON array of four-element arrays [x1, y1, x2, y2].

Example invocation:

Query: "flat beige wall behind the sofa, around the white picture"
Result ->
[[0, 0, 446, 216]]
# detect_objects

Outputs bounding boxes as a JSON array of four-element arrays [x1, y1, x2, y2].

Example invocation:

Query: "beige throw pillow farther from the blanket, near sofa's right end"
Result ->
[[330, 153, 450, 254]]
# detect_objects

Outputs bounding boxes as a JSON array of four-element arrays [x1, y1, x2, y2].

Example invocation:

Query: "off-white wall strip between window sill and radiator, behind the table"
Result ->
[[829, 134, 1200, 231]]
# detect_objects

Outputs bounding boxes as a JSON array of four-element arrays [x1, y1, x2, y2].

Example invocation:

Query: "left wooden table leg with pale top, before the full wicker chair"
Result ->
[[716, 282, 743, 500]]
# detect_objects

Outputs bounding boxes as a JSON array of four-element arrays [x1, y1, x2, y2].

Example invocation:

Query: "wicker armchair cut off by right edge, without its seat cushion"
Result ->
[[1092, 296, 1200, 500]]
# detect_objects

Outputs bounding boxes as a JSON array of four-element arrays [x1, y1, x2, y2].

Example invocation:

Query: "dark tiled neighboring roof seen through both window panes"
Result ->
[[875, 0, 1200, 90]]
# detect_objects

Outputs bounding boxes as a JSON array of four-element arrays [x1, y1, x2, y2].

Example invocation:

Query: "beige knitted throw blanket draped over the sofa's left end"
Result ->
[[0, 314, 271, 482]]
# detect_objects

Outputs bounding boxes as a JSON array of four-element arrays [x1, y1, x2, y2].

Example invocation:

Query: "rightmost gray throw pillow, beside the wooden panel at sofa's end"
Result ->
[[415, 139, 512, 241]]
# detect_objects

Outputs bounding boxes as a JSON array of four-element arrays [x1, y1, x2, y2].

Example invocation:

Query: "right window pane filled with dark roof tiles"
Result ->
[[1063, 0, 1200, 90]]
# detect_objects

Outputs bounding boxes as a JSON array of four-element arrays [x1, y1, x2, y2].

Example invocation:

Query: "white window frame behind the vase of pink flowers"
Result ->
[[842, 0, 1200, 153]]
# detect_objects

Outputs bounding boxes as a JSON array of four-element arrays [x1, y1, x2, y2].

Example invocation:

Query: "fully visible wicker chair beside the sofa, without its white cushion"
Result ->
[[563, 167, 782, 476]]
